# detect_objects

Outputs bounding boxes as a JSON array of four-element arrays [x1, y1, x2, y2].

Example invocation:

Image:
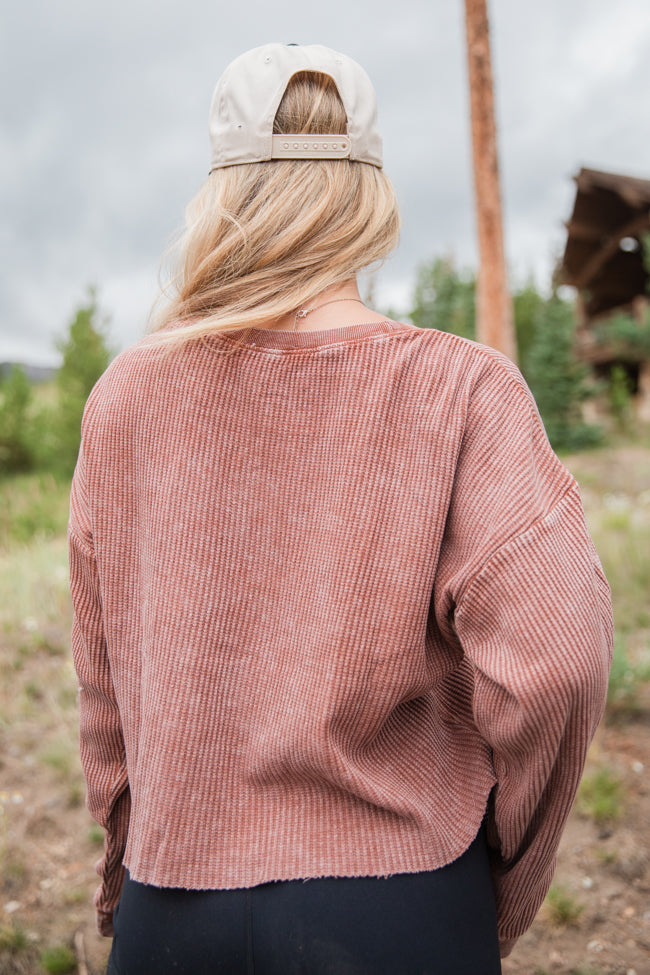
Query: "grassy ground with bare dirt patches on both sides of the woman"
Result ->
[[0, 442, 650, 975]]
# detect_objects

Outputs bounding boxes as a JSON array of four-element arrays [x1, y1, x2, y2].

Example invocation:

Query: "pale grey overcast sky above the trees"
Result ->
[[0, 0, 650, 363]]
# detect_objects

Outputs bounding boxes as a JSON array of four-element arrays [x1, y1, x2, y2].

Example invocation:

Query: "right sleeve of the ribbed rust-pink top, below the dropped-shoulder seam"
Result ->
[[455, 490, 611, 942]]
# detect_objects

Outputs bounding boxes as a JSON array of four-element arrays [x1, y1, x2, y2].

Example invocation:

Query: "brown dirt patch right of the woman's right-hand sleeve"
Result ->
[[502, 688, 650, 975]]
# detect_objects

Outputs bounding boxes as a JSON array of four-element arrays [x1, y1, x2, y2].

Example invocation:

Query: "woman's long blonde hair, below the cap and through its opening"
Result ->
[[152, 72, 399, 339]]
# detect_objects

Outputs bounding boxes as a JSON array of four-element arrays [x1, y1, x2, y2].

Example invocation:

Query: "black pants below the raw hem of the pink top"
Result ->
[[107, 830, 501, 975]]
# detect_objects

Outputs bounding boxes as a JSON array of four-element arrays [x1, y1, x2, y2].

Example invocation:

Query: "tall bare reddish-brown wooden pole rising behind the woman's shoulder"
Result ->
[[465, 0, 517, 362]]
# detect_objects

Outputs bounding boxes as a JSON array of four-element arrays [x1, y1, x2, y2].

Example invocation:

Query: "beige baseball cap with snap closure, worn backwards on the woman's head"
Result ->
[[210, 44, 382, 172]]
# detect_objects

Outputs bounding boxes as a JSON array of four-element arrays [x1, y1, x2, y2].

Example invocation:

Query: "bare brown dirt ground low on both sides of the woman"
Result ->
[[0, 644, 650, 975]]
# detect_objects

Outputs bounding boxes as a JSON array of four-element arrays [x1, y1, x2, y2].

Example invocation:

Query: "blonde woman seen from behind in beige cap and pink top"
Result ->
[[70, 45, 611, 975]]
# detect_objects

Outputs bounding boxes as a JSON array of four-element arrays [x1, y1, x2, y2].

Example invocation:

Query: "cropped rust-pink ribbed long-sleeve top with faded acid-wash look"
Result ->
[[69, 322, 612, 954]]
